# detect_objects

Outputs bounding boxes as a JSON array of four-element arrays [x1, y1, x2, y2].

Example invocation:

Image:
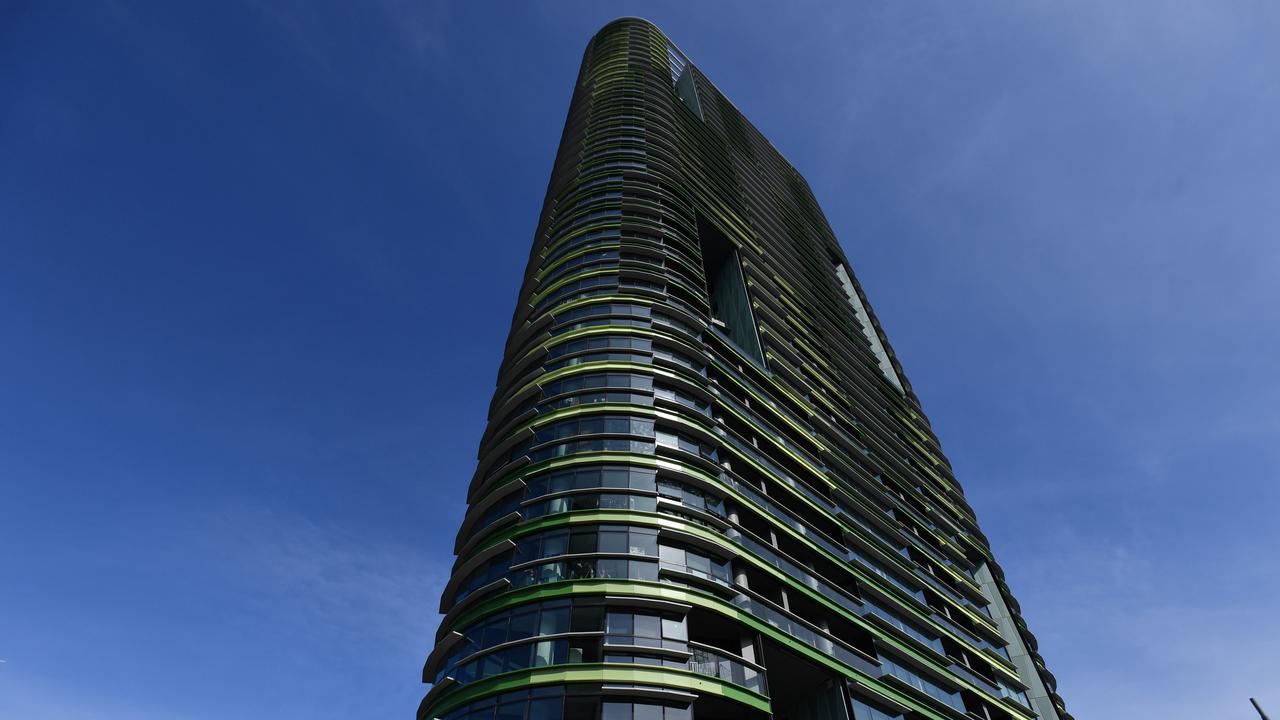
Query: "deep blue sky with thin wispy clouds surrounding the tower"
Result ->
[[0, 0, 1280, 720]]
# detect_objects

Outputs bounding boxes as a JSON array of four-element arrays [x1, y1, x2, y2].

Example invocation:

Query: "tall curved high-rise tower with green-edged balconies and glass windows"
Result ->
[[419, 19, 1071, 720]]
